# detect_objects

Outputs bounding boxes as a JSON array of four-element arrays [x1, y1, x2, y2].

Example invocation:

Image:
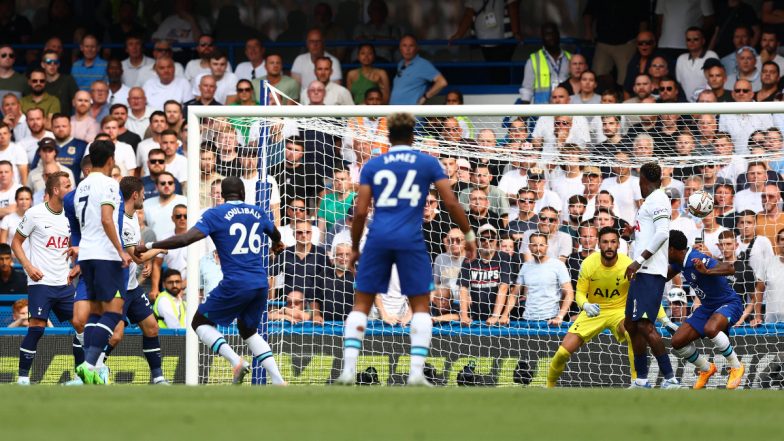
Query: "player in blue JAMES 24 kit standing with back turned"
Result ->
[[336, 113, 476, 386]]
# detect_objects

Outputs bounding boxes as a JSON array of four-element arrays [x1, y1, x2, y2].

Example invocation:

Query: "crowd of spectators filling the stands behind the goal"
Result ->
[[0, 0, 784, 327]]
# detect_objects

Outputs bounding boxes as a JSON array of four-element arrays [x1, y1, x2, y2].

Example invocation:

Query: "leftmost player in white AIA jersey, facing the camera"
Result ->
[[11, 172, 84, 385]]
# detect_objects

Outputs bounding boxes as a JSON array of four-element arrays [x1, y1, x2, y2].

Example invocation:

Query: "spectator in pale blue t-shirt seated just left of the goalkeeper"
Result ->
[[504, 230, 574, 326]]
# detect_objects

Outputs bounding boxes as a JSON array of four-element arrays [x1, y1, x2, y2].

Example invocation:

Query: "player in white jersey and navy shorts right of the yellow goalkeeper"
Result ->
[[624, 162, 680, 388]]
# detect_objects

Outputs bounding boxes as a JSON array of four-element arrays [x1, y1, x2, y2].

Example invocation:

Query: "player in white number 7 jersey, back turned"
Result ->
[[74, 141, 131, 384]]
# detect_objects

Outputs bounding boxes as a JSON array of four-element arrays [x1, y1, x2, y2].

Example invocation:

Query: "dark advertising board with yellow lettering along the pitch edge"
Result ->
[[0, 332, 784, 388]]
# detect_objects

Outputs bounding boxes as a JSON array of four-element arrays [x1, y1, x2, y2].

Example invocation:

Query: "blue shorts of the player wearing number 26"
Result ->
[[199, 282, 269, 328]]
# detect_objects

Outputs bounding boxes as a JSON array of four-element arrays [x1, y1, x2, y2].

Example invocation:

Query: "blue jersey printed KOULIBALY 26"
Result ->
[[195, 201, 275, 289]]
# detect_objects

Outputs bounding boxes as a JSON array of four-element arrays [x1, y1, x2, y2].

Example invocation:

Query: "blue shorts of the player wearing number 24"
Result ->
[[354, 243, 435, 296]]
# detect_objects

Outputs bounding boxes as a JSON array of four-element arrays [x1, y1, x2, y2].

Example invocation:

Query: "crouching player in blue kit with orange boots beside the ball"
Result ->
[[667, 230, 745, 389]]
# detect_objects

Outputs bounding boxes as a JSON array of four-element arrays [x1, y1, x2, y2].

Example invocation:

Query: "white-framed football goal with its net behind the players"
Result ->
[[186, 92, 784, 387]]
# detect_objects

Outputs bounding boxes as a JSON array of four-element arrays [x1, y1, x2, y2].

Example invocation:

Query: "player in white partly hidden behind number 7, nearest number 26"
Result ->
[[98, 176, 169, 384]]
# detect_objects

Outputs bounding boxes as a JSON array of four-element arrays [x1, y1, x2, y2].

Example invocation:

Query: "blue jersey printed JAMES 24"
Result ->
[[359, 145, 447, 249]]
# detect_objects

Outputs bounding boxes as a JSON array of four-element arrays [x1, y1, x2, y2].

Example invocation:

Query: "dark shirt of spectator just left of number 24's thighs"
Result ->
[[305, 266, 354, 322]]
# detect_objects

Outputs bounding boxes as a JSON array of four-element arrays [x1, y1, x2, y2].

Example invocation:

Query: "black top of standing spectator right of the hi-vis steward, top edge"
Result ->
[[583, 0, 648, 45]]
